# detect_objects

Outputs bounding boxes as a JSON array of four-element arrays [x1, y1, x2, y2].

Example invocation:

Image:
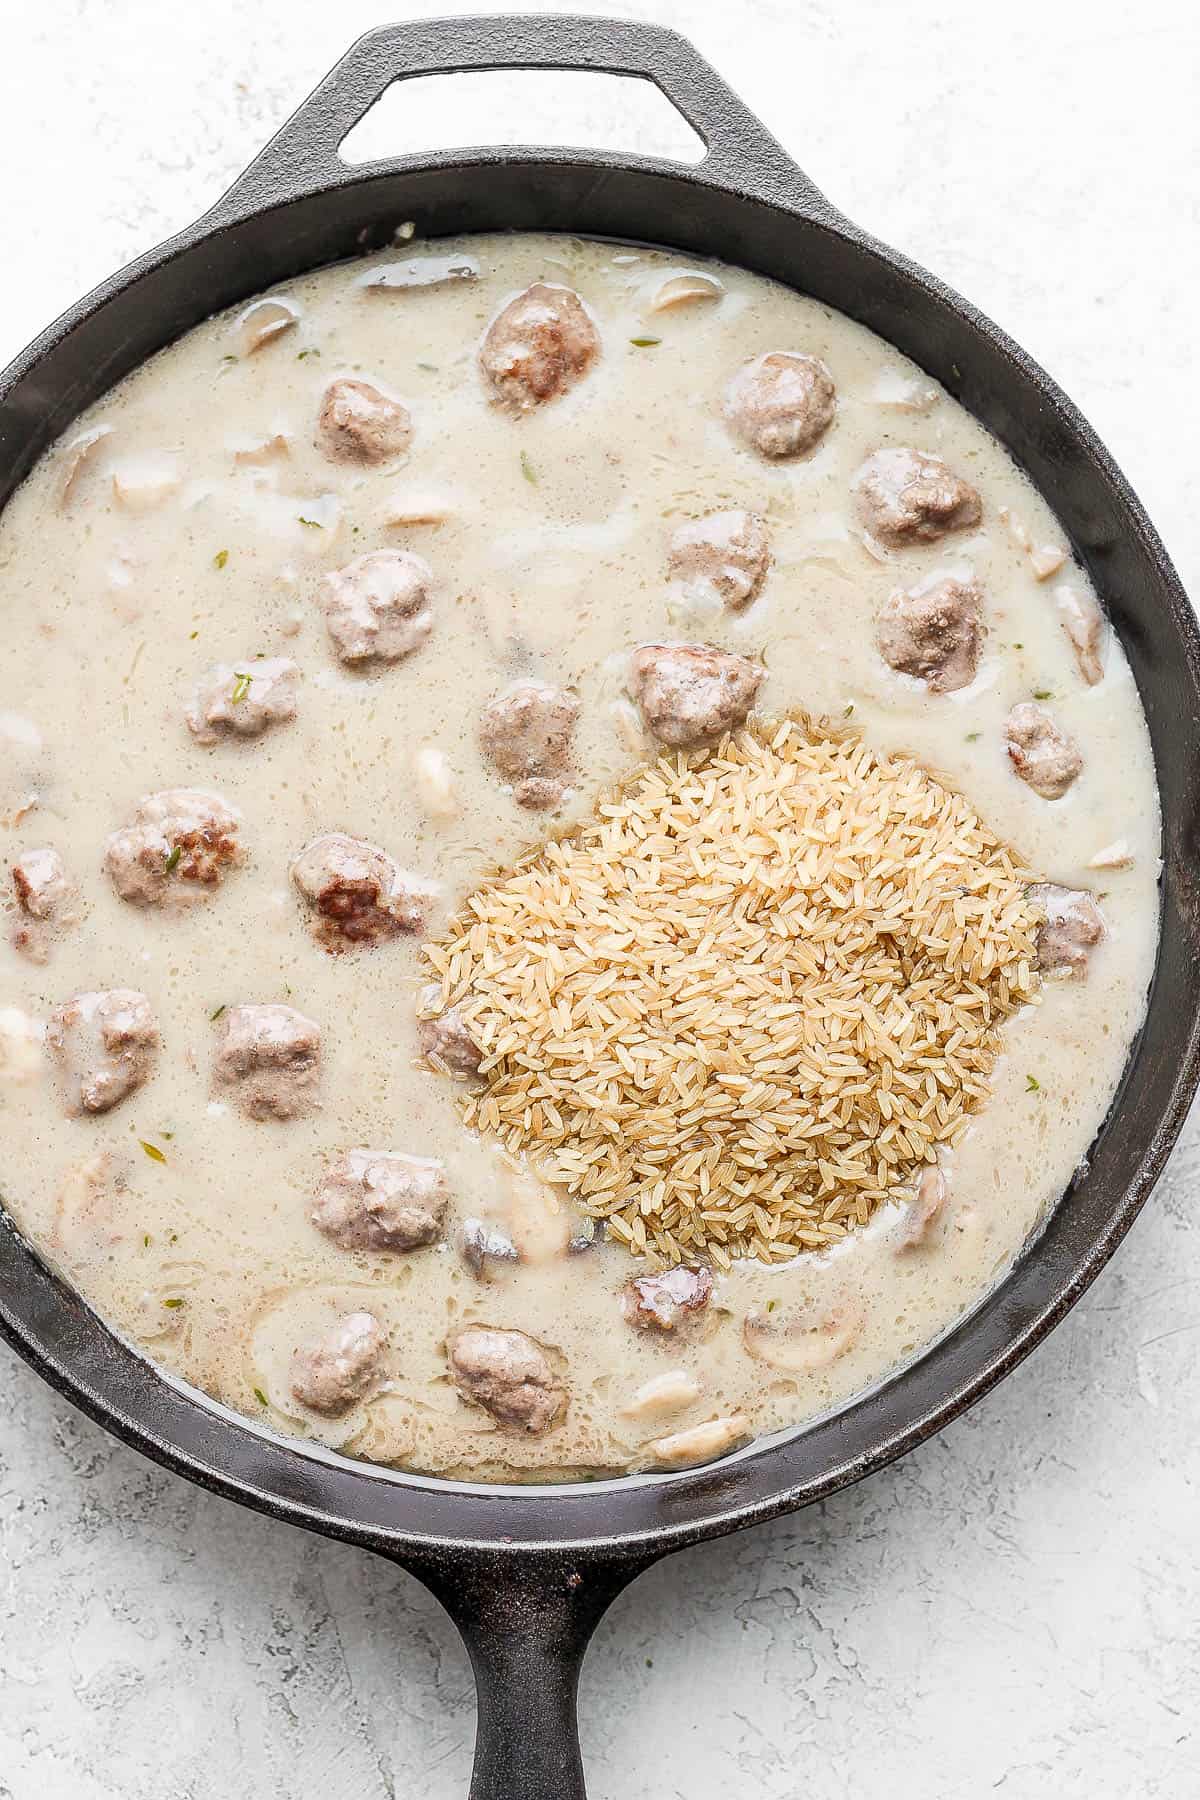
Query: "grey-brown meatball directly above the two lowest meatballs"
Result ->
[[309, 1150, 448, 1249]]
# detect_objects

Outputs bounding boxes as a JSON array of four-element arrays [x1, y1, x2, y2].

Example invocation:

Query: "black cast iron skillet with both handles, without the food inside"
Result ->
[[0, 18, 1200, 1800]]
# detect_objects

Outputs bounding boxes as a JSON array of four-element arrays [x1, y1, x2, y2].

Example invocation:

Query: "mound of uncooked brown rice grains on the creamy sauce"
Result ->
[[426, 718, 1040, 1265]]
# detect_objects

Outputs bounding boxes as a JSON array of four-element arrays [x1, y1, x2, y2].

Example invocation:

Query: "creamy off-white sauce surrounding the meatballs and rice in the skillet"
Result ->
[[0, 236, 1159, 1476]]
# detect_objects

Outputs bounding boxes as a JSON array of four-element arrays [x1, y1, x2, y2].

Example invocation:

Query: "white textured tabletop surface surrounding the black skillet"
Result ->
[[0, 0, 1200, 1800]]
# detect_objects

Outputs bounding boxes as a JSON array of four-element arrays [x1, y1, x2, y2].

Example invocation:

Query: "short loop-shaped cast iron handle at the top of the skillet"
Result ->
[[214, 14, 835, 218]]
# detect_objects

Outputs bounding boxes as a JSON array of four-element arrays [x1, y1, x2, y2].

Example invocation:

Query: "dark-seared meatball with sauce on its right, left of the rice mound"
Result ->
[[291, 832, 434, 952]]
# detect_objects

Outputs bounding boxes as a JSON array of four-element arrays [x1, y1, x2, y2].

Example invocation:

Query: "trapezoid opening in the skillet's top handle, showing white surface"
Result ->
[[338, 68, 707, 167]]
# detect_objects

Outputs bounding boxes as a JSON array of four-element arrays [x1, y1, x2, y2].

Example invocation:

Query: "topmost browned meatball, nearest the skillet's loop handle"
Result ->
[[479, 281, 599, 412]]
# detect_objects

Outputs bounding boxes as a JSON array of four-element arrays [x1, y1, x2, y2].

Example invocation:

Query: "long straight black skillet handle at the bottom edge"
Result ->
[[394, 1540, 657, 1800]]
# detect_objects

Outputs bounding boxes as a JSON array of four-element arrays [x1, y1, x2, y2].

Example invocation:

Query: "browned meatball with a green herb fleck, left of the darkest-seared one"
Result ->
[[104, 788, 243, 905]]
